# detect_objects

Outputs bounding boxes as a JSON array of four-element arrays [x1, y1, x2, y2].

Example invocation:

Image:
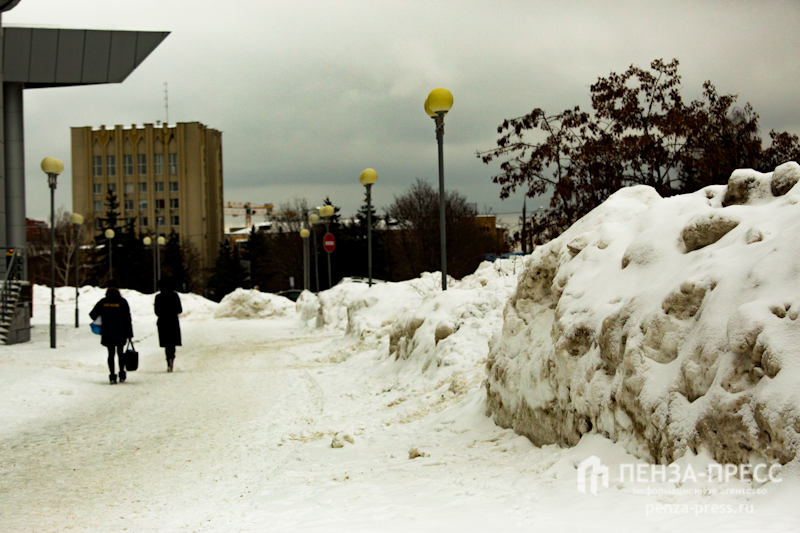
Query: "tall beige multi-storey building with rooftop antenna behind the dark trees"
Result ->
[[72, 122, 224, 278]]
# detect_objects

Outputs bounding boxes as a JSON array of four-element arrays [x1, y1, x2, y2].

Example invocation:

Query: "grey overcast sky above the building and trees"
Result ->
[[3, 0, 800, 231]]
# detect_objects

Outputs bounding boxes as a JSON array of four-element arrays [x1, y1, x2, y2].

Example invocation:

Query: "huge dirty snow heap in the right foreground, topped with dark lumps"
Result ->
[[486, 163, 800, 463]]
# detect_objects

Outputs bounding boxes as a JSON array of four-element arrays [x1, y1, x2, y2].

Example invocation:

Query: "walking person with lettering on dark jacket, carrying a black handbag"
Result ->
[[89, 279, 133, 384]]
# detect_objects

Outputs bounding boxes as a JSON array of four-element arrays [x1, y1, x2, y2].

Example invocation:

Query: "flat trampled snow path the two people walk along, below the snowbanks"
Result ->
[[0, 310, 800, 533]]
